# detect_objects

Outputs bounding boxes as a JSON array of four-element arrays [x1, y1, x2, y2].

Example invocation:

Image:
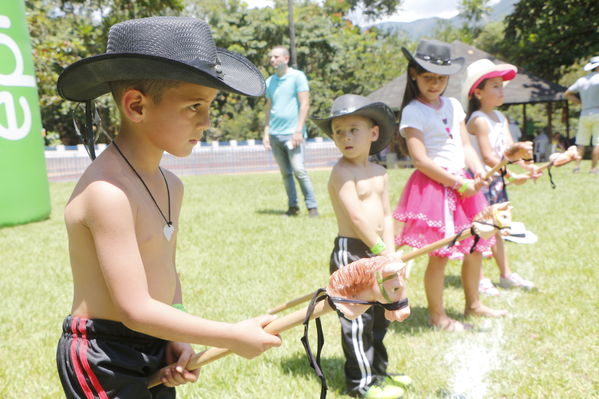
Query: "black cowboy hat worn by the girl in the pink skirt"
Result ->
[[401, 39, 465, 75]]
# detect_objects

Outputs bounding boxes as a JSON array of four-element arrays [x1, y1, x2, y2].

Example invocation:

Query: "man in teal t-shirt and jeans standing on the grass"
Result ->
[[262, 46, 318, 217]]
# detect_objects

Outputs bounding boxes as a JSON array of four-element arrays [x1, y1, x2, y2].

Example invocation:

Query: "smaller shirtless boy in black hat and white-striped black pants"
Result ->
[[313, 94, 410, 399]]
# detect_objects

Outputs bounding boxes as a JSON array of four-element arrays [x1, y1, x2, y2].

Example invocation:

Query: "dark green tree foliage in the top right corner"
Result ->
[[504, 0, 599, 80]]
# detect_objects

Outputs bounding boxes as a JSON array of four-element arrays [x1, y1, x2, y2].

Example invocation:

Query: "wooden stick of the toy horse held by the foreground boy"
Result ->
[[148, 301, 333, 388]]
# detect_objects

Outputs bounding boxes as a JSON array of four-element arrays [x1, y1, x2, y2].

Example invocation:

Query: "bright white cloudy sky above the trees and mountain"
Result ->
[[245, 0, 499, 22]]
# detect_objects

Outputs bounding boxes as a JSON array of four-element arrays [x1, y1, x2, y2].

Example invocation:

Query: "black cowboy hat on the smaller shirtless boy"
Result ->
[[311, 94, 396, 155]]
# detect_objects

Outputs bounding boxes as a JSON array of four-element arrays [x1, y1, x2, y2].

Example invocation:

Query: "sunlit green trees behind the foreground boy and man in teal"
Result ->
[[27, 0, 412, 144]]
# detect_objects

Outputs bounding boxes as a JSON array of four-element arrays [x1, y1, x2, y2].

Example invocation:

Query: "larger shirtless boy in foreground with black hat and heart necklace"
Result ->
[[57, 17, 281, 399]]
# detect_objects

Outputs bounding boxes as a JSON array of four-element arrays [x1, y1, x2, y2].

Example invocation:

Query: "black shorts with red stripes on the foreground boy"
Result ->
[[56, 316, 176, 399]]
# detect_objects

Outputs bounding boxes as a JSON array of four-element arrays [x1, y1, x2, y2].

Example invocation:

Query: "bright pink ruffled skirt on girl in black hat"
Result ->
[[393, 170, 495, 258]]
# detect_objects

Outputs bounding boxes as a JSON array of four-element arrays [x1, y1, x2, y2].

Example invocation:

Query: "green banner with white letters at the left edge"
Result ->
[[0, 0, 50, 226]]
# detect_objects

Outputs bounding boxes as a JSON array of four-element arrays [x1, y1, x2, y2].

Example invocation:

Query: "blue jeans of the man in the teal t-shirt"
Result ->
[[270, 134, 317, 209]]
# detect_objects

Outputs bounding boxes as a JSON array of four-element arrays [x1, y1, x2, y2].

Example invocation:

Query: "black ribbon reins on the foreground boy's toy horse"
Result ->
[[301, 288, 408, 399]]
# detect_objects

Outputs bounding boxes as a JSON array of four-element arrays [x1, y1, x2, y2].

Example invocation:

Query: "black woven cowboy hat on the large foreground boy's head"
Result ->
[[57, 17, 266, 101]]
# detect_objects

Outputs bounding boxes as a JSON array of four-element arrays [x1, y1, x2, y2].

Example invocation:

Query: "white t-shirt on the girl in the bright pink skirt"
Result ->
[[399, 97, 466, 173]]
